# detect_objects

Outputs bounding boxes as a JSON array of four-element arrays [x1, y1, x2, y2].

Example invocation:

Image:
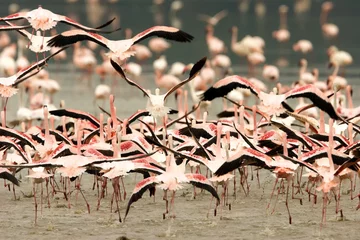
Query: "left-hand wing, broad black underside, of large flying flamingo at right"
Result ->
[[200, 75, 261, 101]]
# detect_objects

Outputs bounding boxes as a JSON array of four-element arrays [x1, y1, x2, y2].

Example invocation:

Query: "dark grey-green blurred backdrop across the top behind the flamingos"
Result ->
[[0, 0, 360, 66]]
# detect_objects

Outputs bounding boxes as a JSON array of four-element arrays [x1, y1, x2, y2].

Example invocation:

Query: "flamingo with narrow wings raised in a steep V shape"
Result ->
[[110, 58, 206, 118]]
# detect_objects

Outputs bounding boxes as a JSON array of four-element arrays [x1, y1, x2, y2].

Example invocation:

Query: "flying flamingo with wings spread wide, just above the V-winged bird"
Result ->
[[47, 26, 194, 61]]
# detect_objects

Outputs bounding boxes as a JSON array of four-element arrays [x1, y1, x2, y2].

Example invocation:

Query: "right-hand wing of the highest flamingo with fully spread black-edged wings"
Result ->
[[132, 26, 194, 44]]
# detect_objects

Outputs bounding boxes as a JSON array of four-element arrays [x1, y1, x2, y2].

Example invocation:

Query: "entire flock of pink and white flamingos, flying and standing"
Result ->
[[0, 1, 360, 227]]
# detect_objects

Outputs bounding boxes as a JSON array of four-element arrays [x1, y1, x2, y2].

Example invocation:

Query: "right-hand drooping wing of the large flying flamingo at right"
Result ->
[[285, 84, 340, 120]]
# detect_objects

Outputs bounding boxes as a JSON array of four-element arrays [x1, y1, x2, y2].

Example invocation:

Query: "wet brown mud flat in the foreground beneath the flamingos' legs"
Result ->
[[0, 170, 360, 239]]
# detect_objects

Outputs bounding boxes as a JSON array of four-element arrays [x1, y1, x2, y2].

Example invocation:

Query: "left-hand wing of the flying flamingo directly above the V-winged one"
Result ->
[[47, 29, 109, 49]]
